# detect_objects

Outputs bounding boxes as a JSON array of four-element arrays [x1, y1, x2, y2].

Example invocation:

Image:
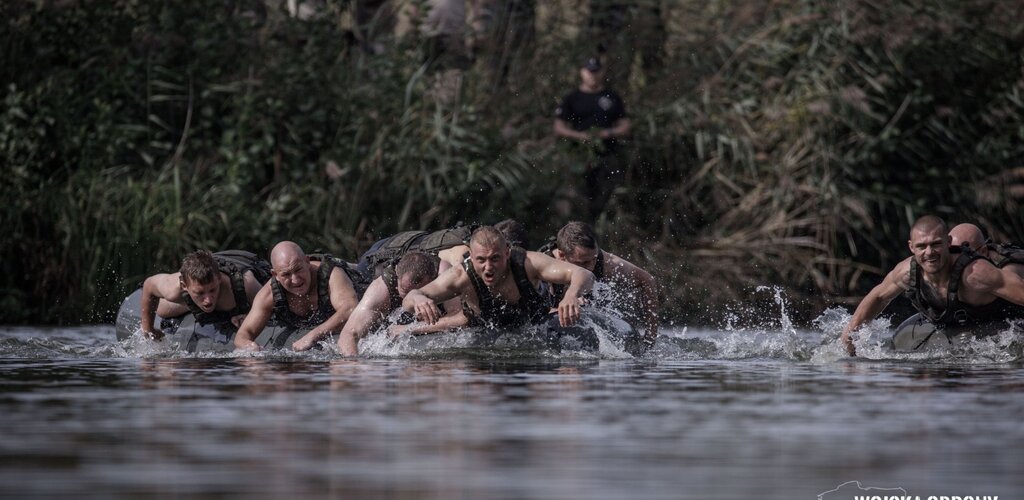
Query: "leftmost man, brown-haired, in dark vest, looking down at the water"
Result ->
[[140, 250, 270, 340]]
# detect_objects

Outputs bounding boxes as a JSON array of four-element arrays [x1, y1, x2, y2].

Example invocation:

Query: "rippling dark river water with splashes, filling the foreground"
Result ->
[[0, 310, 1024, 499]]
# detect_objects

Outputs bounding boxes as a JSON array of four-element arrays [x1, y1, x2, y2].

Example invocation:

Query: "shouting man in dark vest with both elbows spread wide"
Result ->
[[401, 225, 594, 328]]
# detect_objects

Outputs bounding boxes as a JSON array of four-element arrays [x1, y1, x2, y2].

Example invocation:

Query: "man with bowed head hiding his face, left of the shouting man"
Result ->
[[338, 252, 468, 356]]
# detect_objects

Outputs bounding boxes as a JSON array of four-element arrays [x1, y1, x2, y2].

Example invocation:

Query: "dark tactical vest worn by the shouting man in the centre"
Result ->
[[462, 247, 551, 328]]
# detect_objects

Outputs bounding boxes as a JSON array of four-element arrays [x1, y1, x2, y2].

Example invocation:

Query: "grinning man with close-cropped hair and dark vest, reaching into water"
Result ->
[[840, 215, 1024, 356]]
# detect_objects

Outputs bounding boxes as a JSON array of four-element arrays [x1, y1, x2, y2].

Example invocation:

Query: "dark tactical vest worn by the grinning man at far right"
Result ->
[[903, 247, 1020, 326]]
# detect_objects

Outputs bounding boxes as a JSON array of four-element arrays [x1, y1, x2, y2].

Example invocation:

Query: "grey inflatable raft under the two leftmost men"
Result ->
[[115, 289, 309, 352]]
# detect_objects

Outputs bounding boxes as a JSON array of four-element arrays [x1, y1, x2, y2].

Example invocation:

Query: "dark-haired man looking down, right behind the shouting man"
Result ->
[[551, 221, 657, 346]]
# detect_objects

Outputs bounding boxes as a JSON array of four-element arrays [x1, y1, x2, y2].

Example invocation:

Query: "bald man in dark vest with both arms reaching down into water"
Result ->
[[234, 242, 359, 350]]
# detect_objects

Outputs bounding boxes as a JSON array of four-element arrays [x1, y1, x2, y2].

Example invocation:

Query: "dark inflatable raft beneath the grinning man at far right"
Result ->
[[892, 313, 1008, 352]]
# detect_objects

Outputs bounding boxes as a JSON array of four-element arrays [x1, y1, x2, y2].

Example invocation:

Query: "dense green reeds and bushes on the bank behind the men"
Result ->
[[0, 0, 1024, 323]]
